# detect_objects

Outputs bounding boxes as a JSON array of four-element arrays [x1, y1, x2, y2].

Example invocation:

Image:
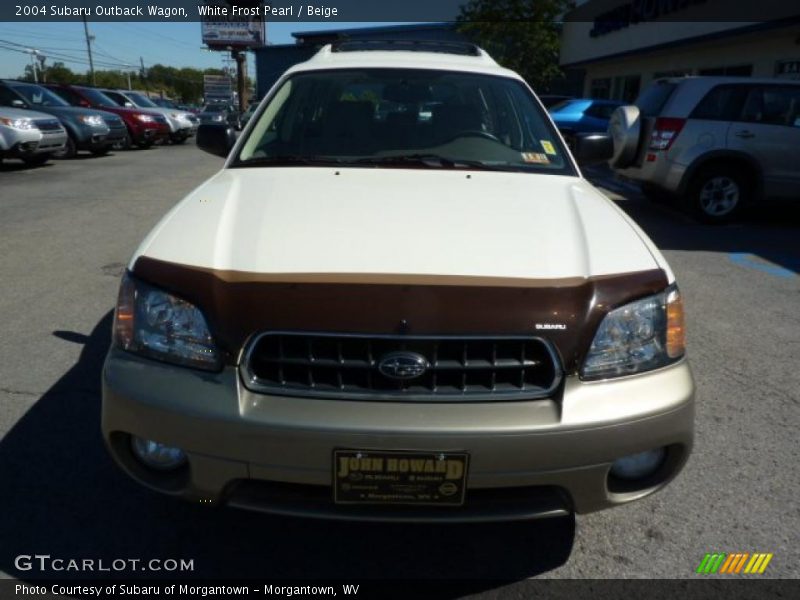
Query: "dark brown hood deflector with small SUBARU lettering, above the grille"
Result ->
[[133, 256, 668, 373]]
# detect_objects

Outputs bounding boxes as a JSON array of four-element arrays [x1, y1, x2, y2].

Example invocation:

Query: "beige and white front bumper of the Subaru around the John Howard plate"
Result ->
[[102, 349, 694, 521]]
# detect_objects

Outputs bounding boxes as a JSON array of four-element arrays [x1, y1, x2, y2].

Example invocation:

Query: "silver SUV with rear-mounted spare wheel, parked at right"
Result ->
[[609, 77, 800, 222]]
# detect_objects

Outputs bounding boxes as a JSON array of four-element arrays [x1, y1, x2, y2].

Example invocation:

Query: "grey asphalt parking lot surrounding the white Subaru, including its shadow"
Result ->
[[0, 143, 800, 593]]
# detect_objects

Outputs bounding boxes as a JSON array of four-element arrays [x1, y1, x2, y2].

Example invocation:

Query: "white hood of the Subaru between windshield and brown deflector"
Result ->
[[131, 167, 662, 282]]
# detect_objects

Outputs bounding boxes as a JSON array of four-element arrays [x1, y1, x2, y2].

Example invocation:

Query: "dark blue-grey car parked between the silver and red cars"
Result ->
[[0, 80, 125, 158]]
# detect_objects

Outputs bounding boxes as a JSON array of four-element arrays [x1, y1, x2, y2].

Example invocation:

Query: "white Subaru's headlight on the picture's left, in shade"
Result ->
[[114, 273, 221, 371]]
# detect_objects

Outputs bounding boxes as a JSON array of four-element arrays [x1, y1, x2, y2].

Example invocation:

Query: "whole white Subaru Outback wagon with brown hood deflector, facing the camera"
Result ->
[[102, 42, 694, 521]]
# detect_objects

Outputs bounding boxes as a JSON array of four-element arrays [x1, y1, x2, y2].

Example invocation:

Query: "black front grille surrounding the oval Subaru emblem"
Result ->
[[242, 332, 562, 402]]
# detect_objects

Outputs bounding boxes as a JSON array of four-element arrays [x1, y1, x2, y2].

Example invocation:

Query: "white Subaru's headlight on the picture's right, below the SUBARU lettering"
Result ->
[[581, 286, 686, 379]]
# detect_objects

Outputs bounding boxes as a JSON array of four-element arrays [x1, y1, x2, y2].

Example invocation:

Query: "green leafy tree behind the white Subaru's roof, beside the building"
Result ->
[[457, 0, 574, 92]]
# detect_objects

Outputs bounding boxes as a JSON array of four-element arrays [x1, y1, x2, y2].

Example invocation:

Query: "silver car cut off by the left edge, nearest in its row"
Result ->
[[0, 107, 67, 165]]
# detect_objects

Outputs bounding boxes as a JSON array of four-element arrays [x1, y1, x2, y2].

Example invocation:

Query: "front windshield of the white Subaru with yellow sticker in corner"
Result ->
[[232, 69, 574, 174]]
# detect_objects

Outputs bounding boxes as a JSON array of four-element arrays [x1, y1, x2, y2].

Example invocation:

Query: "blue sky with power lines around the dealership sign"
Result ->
[[0, 21, 404, 78]]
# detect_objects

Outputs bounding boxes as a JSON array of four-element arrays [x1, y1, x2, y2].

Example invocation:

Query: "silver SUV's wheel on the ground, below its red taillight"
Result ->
[[686, 165, 752, 224]]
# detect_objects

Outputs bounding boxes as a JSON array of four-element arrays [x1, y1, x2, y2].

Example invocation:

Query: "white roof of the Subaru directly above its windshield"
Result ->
[[286, 44, 522, 80]]
